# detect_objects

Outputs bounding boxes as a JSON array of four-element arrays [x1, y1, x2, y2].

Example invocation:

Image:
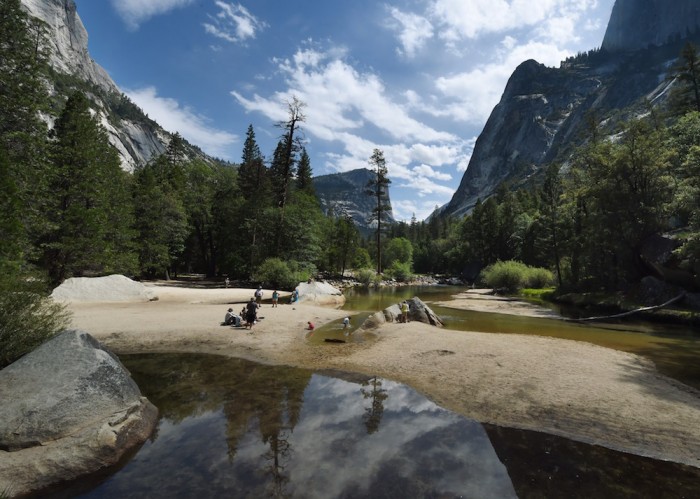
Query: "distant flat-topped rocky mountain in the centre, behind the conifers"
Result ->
[[313, 168, 394, 234]]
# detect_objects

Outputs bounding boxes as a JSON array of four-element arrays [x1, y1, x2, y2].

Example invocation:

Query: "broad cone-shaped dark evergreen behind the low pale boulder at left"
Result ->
[[43, 92, 133, 283]]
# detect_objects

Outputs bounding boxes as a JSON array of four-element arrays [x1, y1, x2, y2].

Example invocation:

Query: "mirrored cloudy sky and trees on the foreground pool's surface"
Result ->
[[56, 354, 515, 498]]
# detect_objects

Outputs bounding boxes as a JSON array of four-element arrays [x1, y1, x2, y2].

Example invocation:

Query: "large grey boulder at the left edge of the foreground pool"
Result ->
[[0, 330, 158, 496]]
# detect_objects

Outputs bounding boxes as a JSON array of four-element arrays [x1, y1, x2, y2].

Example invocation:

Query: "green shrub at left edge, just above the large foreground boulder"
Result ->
[[0, 276, 70, 369]]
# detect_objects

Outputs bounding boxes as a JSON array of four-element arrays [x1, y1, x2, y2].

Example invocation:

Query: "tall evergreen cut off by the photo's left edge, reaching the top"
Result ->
[[0, 0, 48, 268]]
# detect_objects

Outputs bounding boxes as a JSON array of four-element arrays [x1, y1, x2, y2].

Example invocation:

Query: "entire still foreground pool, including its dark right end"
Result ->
[[47, 354, 700, 498]]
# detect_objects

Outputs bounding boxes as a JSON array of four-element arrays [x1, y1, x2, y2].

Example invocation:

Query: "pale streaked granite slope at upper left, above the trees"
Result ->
[[22, 0, 183, 171]]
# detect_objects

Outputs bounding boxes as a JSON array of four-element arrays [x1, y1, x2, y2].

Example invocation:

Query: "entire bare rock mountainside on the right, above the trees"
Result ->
[[440, 0, 700, 217]]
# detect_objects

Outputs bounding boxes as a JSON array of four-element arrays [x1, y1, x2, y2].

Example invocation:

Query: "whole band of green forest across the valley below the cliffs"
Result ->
[[0, 0, 700, 296]]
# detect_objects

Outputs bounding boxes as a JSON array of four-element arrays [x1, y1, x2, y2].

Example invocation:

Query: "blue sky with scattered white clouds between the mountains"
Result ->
[[75, 0, 614, 220]]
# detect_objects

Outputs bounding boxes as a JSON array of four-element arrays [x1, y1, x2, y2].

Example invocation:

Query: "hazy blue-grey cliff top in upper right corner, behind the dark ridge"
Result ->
[[602, 0, 700, 52]]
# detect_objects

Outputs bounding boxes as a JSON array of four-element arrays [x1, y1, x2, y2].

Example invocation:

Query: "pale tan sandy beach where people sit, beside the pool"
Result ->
[[68, 284, 700, 467]]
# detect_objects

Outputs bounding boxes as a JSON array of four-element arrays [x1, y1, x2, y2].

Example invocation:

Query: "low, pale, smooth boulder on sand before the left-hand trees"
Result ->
[[51, 274, 158, 302]]
